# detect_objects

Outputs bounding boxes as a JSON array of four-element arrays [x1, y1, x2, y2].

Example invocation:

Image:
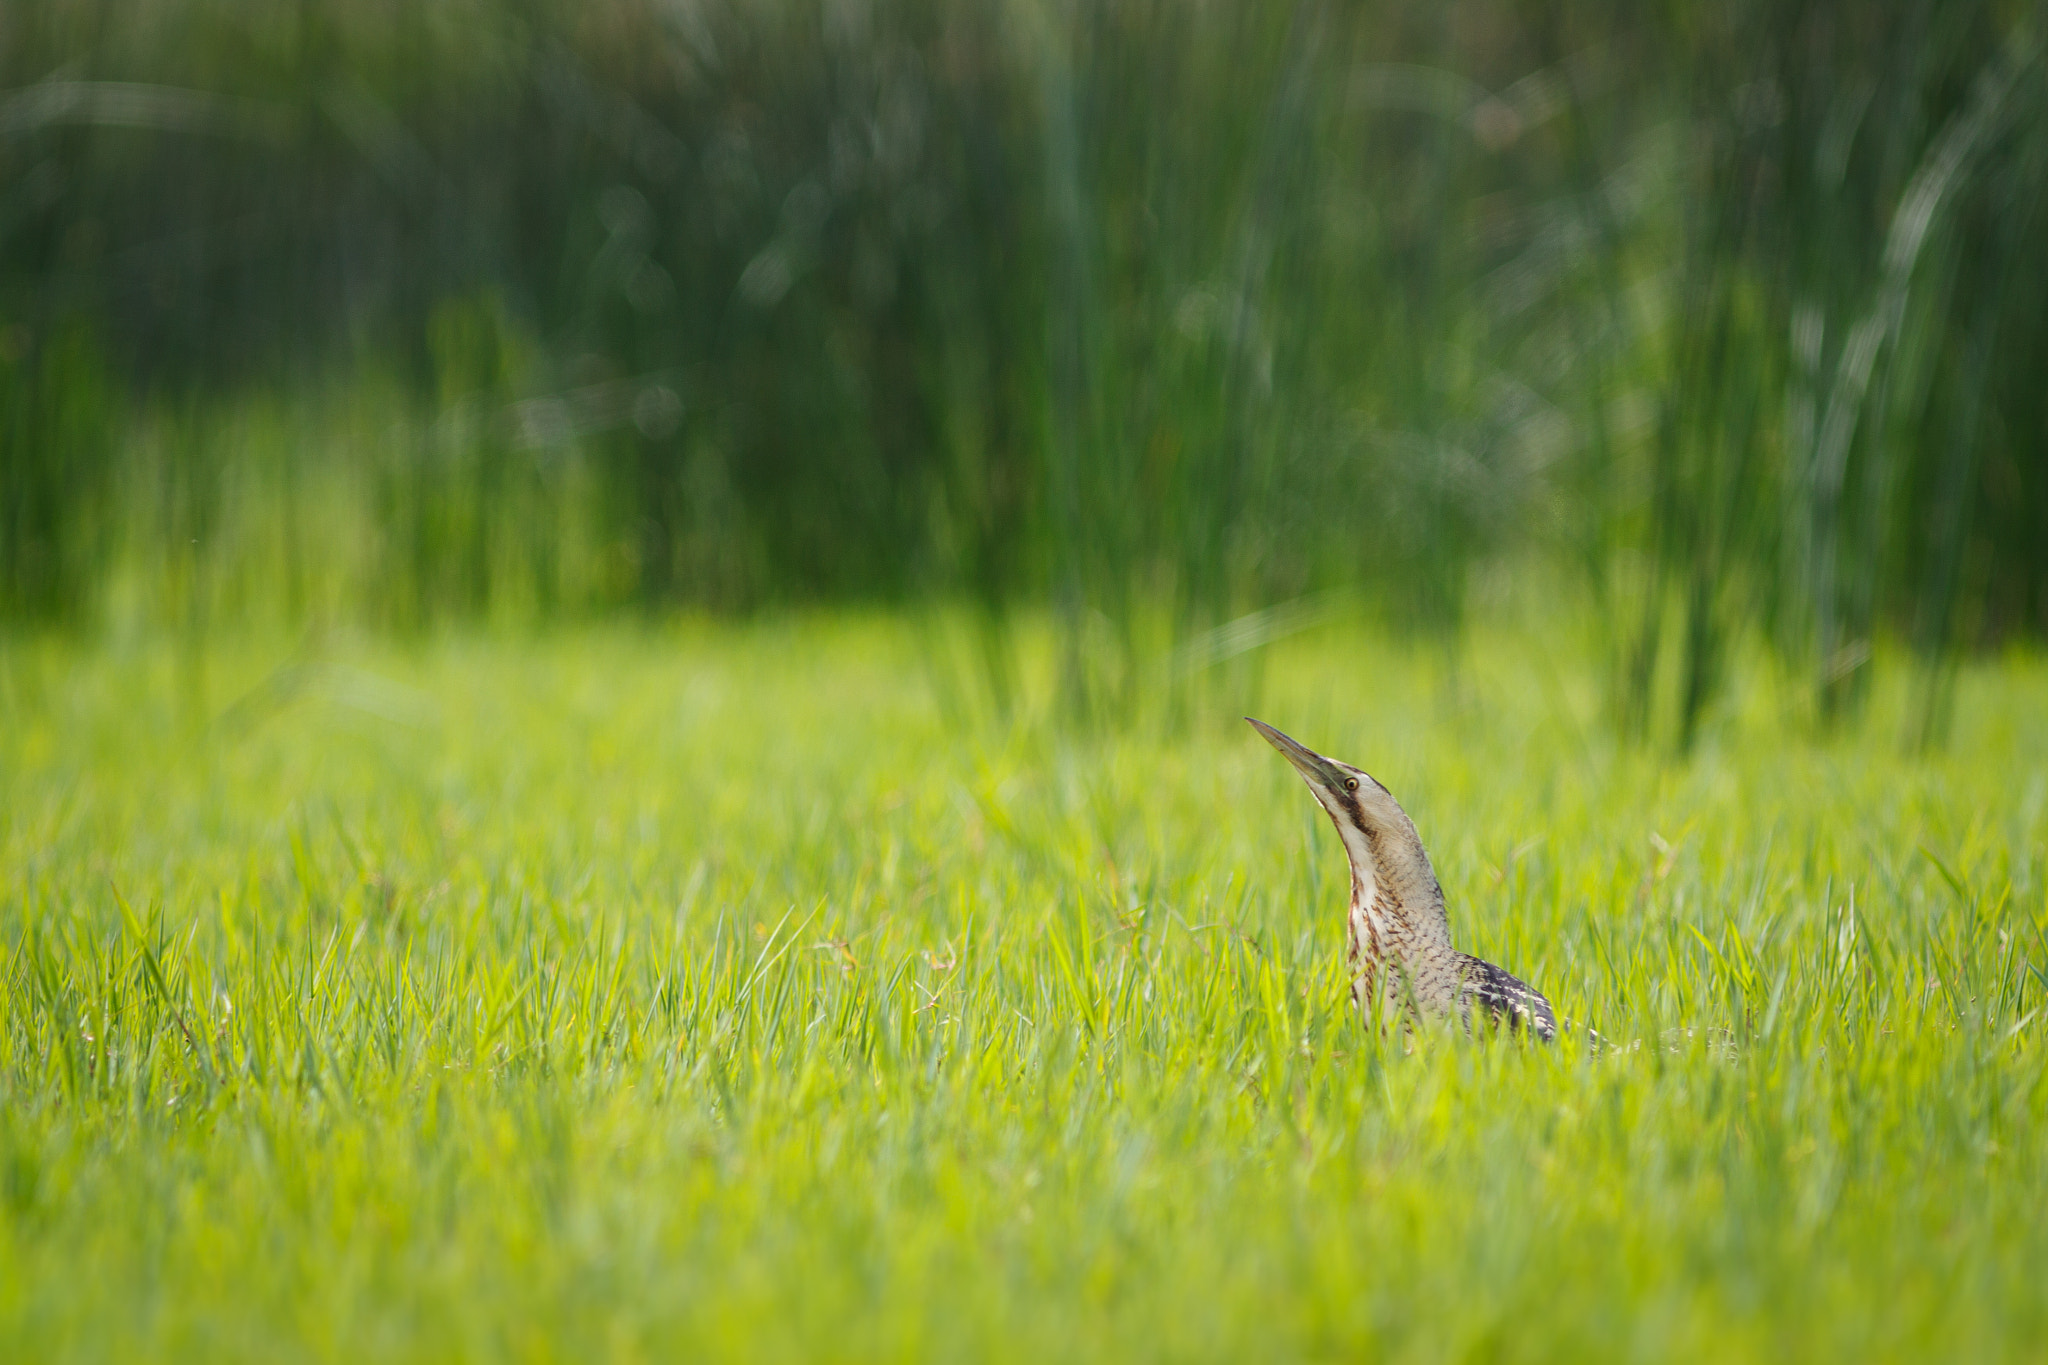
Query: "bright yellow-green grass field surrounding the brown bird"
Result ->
[[0, 618, 2048, 1361]]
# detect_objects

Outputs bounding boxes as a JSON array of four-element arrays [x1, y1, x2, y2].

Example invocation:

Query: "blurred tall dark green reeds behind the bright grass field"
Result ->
[[0, 0, 2048, 743]]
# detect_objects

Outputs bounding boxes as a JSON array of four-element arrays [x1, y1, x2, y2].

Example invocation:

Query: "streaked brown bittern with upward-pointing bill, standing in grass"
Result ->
[[1245, 716, 1556, 1042]]
